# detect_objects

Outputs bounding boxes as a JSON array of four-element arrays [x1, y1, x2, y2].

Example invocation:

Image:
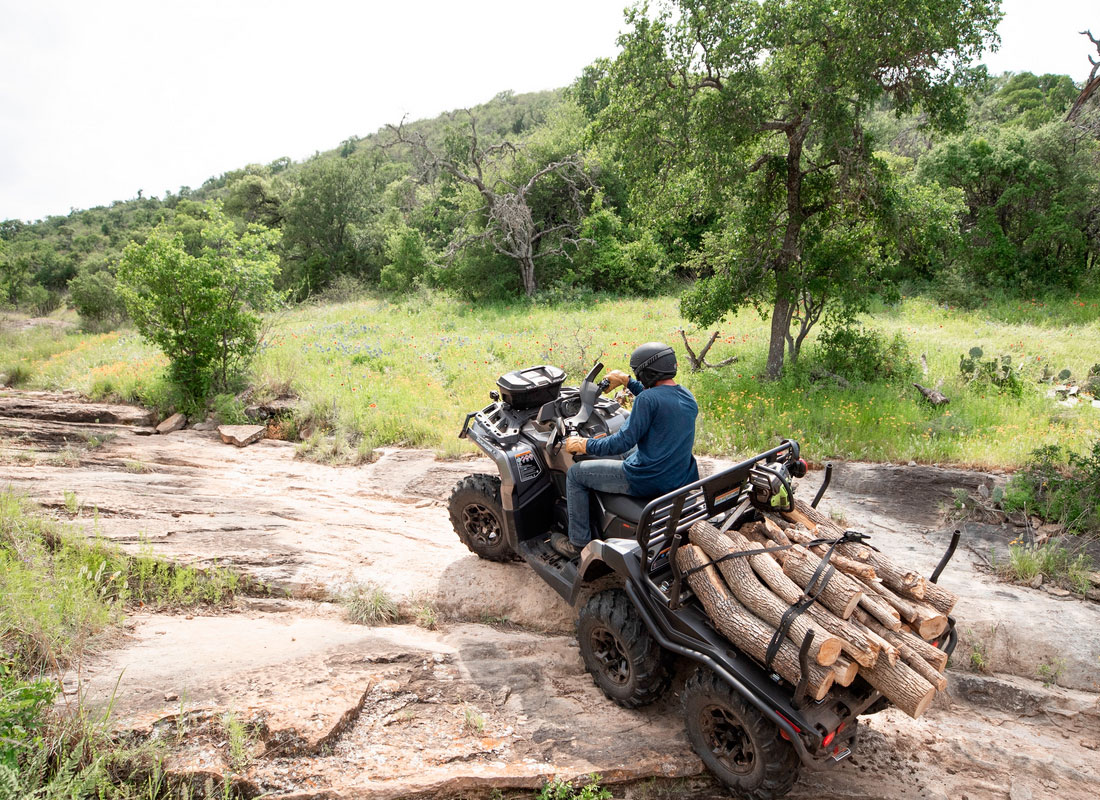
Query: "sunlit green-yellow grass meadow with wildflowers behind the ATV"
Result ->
[[0, 295, 1100, 468]]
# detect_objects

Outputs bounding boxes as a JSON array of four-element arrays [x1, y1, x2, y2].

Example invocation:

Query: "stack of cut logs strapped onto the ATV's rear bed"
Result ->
[[677, 502, 956, 717]]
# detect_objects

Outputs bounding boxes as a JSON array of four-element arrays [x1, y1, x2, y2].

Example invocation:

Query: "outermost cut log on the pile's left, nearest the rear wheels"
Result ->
[[677, 545, 836, 700]]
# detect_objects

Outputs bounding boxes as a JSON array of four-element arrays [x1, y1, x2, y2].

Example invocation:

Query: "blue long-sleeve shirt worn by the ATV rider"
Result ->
[[585, 381, 699, 497]]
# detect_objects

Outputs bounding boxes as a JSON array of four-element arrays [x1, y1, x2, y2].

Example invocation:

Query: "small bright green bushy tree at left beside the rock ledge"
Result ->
[[118, 206, 279, 403]]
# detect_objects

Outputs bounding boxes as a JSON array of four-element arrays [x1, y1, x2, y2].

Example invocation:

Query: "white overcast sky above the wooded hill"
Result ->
[[0, 0, 1100, 220]]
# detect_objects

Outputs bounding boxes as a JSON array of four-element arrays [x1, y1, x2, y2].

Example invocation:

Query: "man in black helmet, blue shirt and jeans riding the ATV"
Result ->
[[550, 342, 699, 559]]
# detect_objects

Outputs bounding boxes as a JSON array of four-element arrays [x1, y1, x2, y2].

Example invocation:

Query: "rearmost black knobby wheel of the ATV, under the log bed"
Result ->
[[683, 668, 801, 800]]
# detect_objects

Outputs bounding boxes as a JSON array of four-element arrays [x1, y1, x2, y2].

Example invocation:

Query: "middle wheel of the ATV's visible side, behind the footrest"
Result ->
[[576, 589, 670, 709]]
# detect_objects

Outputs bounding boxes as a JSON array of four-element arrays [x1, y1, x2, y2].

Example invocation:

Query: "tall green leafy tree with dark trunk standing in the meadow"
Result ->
[[597, 0, 1000, 377]]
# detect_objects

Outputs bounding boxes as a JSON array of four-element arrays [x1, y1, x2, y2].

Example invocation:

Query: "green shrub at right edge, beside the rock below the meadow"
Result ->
[[1002, 439, 1100, 533]]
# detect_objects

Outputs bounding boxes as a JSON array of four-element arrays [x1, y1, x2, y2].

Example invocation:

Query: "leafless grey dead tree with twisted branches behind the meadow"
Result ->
[[388, 110, 591, 297]]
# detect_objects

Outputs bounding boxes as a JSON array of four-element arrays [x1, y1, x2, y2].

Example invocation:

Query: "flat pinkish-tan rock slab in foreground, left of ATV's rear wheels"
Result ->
[[73, 601, 703, 797]]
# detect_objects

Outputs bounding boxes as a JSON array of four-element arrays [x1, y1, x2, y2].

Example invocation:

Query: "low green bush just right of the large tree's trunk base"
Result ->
[[816, 324, 916, 382]]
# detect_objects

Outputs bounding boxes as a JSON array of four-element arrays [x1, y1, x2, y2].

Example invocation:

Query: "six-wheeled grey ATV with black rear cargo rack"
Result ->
[[449, 363, 956, 800]]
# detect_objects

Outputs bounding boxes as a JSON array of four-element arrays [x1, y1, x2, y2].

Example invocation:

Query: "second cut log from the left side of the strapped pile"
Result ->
[[689, 520, 842, 667]]
